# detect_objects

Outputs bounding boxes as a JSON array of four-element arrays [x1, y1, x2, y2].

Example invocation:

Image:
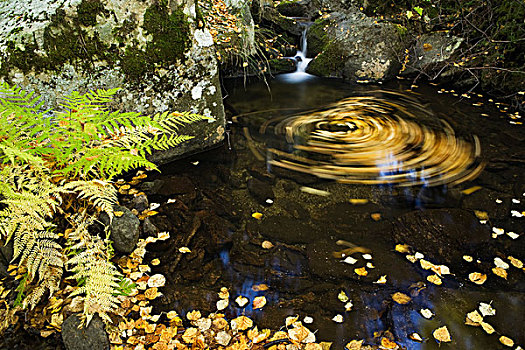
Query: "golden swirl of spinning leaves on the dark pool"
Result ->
[[237, 91, 484, 186]]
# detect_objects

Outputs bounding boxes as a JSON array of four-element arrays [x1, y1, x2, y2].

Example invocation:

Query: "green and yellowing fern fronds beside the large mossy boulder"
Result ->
[[0, 83, 208, 322]]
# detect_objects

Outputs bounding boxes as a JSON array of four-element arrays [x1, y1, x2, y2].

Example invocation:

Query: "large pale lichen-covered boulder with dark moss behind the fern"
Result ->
[[0, 0, 224, 162]]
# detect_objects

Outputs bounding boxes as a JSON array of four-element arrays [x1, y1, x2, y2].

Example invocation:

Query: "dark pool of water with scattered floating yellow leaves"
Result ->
[[142, 75, 525, 349]]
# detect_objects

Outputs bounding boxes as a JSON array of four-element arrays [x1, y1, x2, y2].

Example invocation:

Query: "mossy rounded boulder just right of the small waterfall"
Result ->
[[300, 1, 403, 81]]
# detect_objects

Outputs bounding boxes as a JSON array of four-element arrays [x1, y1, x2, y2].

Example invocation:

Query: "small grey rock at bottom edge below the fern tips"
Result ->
[[62, 315, 109, 350]]
